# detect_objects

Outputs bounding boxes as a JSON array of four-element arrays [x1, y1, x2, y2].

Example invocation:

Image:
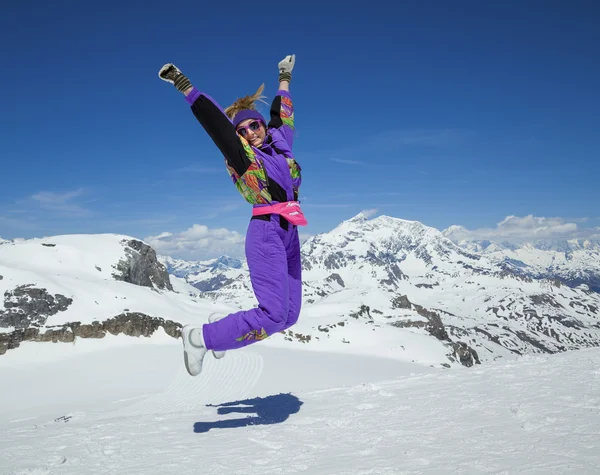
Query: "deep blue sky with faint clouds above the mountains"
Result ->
[[0, 0, 600, 258]]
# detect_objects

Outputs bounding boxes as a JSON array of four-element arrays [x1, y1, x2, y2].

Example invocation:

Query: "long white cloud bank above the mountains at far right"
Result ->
[[445, 218, 600, 242]]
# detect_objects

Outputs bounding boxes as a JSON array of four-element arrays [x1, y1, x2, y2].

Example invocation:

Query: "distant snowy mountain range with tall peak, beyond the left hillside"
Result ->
[[161, 214, 600, 364]]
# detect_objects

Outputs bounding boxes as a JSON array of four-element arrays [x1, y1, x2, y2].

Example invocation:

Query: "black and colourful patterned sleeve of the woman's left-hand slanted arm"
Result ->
[[186, 89, 271, 204]]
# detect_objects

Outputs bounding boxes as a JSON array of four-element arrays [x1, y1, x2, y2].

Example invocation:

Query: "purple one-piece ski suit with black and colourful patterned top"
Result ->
[[186, 88, 302, 351]]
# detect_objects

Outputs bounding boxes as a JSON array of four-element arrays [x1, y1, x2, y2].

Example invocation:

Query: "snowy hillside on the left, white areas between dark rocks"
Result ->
[[0, 234, 239, 333]]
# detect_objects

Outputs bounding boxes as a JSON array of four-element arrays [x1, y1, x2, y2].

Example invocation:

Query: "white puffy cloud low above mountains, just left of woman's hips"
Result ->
[[144, 224, 245, 260]]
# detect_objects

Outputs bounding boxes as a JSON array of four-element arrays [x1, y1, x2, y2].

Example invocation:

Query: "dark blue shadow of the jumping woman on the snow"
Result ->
[[194, 393, 304, 433]]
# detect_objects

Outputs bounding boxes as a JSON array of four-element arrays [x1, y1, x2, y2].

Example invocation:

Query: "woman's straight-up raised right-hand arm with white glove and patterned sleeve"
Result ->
[[269, 54, 296, 148]]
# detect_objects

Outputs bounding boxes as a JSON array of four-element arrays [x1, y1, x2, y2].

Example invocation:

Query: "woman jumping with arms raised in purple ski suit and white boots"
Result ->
[[158, 55, 307, 376]]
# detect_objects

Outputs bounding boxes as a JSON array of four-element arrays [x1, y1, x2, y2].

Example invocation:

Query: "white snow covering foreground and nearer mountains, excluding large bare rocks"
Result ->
[[0, 226, 600, 475]]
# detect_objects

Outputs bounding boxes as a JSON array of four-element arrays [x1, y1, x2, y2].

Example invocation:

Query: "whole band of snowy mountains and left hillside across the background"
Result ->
[[0, 214, 600, 367]]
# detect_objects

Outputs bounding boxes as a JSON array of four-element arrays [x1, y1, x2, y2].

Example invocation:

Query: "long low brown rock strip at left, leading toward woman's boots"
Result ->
[[0, 312, 181, 355]]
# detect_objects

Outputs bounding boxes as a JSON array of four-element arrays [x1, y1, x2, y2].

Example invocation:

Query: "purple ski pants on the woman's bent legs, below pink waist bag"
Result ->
[[203, 214, 302, 351]]
